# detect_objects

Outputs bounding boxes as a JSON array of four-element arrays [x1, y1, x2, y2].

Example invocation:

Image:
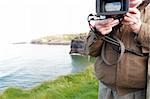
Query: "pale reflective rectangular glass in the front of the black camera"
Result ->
[[105, 2, 121, 11]]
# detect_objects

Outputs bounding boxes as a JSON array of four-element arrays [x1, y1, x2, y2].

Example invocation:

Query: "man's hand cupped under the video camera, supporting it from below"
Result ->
[[95, 18, 119, 35]]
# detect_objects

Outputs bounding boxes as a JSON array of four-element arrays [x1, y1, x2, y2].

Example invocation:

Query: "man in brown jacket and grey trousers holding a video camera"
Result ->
[[87, 0, 150, 99]]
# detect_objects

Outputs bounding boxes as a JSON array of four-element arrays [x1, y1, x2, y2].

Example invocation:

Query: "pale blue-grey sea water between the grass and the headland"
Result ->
[[0, 44, 93, 91]]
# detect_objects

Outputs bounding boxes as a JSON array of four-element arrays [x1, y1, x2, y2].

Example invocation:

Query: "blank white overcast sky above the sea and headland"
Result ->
[[0, 0, 95, 42]]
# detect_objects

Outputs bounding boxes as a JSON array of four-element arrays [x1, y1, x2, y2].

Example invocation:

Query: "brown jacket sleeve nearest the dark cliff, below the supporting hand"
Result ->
[[87, 31, 103, 57]]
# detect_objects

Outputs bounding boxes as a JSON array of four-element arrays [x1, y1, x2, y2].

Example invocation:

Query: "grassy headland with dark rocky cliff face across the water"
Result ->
[[30, 33, 87, 55]]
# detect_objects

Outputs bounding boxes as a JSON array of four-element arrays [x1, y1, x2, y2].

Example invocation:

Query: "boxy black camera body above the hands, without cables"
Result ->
[[96, 0, 129, 18]]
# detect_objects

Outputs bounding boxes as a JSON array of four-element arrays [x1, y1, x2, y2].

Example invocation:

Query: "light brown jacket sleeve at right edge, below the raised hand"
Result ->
[[137, 6, 150, 53]]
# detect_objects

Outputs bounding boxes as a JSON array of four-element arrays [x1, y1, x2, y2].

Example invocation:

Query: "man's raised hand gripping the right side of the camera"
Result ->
[[122, 8, 142, 33]]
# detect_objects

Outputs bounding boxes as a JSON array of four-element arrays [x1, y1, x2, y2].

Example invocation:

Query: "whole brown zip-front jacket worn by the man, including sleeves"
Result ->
[[87, 5, 150, 95]]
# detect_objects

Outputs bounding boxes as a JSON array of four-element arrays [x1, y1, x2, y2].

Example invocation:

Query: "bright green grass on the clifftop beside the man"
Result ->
[[0, 67, 98, 99]]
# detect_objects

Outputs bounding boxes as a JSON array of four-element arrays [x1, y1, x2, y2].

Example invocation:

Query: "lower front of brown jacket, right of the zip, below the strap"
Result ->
[[118, 53, 147, 88]]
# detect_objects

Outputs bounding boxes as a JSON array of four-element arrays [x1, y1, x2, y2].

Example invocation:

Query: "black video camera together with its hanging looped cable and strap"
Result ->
[[87, 0, 130, 66]]
